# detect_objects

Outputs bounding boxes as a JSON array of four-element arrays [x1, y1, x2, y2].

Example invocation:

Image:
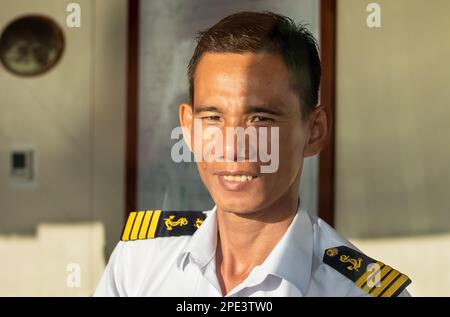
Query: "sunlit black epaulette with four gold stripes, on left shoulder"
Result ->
[[121, 210, 206, 241]]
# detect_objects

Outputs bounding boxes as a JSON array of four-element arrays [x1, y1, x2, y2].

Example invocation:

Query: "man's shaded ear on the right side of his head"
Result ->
[[303, 106, 329, 157]]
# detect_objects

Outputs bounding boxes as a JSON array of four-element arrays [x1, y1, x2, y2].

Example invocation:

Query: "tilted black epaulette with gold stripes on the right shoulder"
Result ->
[[323, 246, 411, 297]]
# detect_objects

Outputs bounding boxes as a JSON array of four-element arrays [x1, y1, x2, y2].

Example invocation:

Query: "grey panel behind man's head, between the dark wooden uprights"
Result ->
[[138, 0, 319, 213]]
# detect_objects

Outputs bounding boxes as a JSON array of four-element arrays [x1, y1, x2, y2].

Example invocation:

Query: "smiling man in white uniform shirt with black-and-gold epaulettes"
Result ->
[[96, 12, 410, 296]]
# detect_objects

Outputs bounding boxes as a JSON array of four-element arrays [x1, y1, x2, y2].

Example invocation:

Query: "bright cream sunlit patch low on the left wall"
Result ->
[[0, 223, 105, 296]]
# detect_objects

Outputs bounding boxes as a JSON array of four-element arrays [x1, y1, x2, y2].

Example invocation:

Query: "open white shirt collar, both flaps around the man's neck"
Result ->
[[177, 206, 313, 294]]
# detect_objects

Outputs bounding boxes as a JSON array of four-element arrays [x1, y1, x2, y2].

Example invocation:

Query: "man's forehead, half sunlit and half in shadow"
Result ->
[[194, 52, 297, 105]]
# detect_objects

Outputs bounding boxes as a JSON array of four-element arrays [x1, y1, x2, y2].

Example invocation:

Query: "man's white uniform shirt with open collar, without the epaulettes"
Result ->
[[95, 207, 409, 297]]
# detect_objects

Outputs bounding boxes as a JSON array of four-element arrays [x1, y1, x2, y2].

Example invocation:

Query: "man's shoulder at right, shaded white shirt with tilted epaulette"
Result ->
[[310, 212, 411, 297]]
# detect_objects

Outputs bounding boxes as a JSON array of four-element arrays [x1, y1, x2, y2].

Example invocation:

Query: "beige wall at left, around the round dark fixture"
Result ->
[[0, 0, 127, 295]]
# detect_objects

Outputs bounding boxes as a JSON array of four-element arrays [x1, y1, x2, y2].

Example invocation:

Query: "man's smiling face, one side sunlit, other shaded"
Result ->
[[180, 53, 316, 214]]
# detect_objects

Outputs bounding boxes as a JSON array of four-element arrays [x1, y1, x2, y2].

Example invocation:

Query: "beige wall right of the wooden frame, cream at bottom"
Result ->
[[336, 0, 450, 296]]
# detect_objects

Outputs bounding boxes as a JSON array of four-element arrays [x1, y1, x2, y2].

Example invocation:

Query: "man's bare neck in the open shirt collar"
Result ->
[[216, 175, 299, 294]]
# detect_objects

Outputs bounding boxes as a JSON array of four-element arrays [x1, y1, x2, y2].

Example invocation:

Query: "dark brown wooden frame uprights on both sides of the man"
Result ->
[[125, 0, 336, 226]]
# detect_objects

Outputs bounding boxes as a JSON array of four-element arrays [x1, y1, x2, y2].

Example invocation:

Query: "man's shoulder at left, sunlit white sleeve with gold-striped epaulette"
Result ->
[[97, 210, 207, 296]]
